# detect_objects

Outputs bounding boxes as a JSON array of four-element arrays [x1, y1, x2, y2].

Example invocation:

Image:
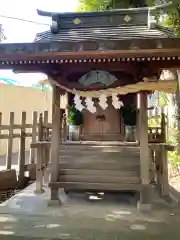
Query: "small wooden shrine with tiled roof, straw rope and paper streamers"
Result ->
[[0, 4, 180, 209]]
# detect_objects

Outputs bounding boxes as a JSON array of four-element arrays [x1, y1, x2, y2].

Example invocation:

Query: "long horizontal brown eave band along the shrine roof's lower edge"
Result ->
[[0, 38, 180, 64]]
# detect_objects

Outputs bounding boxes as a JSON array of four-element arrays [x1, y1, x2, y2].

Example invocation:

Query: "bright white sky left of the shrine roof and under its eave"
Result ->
[[0, 0, 78, 85]]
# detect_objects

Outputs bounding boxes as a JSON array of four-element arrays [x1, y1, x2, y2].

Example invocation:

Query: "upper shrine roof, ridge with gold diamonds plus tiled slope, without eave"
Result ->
[[35, 8, 175, 42]]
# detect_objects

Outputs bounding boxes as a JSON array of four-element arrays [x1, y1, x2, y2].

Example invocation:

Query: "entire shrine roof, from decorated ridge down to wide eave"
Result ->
[[0, 8, 180, 69]]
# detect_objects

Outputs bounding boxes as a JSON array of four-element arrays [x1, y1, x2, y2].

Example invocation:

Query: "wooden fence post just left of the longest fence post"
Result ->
[[6, 112, 14, 169]]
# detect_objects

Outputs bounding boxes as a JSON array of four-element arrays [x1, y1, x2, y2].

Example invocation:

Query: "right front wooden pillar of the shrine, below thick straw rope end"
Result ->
[[138, 92, 151, 210]]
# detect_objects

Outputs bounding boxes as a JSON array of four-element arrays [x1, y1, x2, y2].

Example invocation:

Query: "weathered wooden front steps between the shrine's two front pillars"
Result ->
[[49, 142, 151, 191]]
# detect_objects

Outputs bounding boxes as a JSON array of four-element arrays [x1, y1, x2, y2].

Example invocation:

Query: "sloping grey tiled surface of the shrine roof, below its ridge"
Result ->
[[35, 25, 174, 42]]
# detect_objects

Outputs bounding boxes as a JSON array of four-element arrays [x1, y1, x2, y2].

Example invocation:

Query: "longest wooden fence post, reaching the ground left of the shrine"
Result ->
[[18, 112, 26, 187]]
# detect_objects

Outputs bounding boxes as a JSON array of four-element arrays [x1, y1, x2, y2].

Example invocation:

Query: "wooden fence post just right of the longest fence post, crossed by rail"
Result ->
[[30, 111, 37, 164]]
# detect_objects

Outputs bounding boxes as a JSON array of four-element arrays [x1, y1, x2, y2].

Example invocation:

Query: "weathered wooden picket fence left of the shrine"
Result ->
[[0, 111, 52, 188]]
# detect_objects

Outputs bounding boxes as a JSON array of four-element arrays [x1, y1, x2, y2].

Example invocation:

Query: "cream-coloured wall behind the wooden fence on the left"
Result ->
[[0, 85, 65, 155]]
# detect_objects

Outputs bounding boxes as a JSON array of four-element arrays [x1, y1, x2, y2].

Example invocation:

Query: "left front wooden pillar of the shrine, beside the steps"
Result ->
[[50, 85, 61, 204]]
